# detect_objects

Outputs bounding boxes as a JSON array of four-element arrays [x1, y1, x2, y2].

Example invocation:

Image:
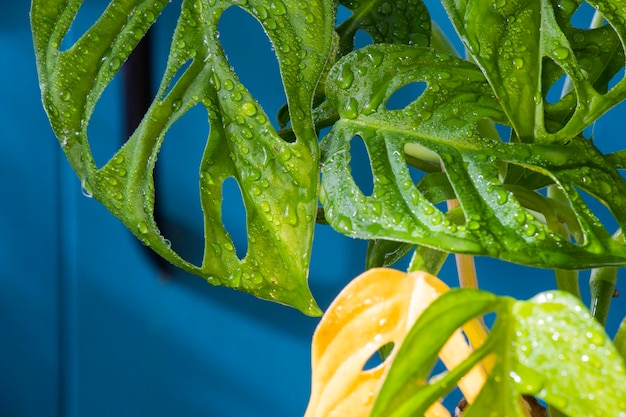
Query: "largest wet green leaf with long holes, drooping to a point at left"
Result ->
[[31, 0, 335, 314]]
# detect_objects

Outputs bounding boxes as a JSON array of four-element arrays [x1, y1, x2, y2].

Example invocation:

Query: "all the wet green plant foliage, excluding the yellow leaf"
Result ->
[[31, 0, 626, 416]]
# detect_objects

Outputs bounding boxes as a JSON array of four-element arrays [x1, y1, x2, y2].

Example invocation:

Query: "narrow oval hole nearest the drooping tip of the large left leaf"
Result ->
[[222, 177, 248, 259]]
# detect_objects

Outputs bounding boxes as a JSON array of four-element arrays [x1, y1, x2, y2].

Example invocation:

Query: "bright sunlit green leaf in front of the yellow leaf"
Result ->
[[371, 289, 626, 417]]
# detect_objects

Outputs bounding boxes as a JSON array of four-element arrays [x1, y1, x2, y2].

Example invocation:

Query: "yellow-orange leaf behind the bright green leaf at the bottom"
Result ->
[[305, 268, 486, 417]]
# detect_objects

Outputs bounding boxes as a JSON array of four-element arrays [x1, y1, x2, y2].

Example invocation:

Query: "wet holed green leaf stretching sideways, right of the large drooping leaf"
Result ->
[[320, 45, 626, 269]]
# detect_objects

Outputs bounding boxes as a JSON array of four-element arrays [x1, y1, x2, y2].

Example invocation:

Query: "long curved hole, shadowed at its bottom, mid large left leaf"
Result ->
[[155, 105, 209, 265]]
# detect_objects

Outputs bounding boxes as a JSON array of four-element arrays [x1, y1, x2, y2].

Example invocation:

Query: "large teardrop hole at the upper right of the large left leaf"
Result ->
[[218, 7, 284, 129]]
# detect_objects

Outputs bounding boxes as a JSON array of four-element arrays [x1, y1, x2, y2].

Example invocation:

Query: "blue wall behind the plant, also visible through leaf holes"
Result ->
[[0, 1, 626, 417]]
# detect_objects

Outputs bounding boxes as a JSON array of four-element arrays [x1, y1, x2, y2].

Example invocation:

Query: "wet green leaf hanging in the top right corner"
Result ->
[[443, 0, 626, 143]]
